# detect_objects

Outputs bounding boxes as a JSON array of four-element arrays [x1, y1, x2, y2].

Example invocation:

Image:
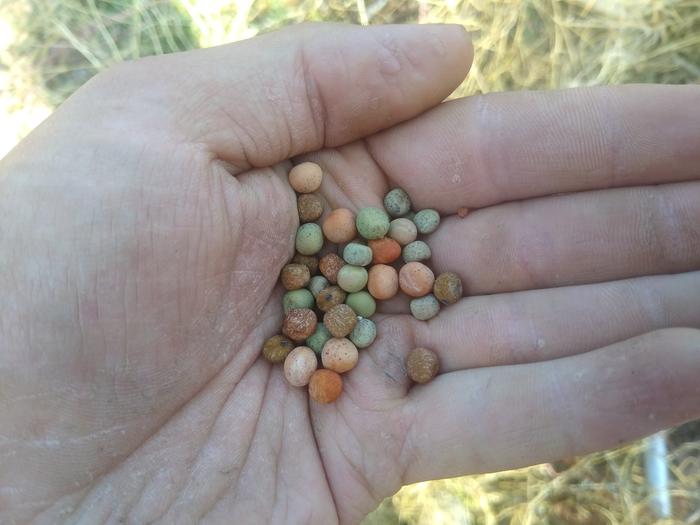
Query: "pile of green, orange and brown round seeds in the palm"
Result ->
[[262, 162, 462, 403]]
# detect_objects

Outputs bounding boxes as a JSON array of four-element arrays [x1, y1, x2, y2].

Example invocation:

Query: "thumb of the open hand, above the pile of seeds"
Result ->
[[74, 24, 472, 170]]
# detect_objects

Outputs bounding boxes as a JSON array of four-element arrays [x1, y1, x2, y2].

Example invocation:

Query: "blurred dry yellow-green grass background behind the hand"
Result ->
[[0, 0, 700, 525]]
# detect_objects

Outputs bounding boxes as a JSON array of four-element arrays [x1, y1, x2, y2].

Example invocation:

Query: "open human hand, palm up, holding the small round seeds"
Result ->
[[0, 25, 700, 523]]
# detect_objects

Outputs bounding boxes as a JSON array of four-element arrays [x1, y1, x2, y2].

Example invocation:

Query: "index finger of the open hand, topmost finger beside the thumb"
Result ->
[[367, 85, 700, 213]]
